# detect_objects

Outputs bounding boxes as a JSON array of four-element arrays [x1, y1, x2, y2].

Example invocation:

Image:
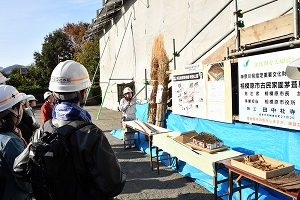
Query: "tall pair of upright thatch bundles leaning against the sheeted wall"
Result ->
[[148, 35, 169, 127]]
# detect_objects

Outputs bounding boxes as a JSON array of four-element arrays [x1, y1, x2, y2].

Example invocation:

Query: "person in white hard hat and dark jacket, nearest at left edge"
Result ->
[[0, 85, 32, 200]]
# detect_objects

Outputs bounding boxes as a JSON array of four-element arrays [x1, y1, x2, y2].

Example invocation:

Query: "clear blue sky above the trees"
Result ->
[[0, 0, 102, 67]]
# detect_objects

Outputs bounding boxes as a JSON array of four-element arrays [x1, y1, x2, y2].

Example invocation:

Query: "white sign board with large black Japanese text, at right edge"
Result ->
[[238, 49, 300, 130]]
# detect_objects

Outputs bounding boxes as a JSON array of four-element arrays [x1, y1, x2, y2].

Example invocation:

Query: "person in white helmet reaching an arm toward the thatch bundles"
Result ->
[[119, 87, 148, 149]]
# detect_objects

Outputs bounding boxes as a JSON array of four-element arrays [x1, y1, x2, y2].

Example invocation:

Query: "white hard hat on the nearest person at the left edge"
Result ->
[[0, 85, 23, 112]]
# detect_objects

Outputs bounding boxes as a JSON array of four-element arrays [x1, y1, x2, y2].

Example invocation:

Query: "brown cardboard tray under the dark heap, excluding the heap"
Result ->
[[174, 131, 230, 153]]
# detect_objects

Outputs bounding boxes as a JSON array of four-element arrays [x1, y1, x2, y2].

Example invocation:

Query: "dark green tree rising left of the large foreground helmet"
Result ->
[[33, 29, 74, 87]]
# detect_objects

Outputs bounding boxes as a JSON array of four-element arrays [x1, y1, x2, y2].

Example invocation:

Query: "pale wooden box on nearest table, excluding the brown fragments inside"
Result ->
[[231, 155, 294, 179]]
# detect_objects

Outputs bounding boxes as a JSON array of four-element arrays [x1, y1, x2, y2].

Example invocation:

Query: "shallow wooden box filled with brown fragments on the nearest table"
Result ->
[[231, 154, 294, 179]]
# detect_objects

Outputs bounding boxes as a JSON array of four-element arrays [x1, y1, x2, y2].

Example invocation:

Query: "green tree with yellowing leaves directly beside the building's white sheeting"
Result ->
[[74, 37, 100, 82]]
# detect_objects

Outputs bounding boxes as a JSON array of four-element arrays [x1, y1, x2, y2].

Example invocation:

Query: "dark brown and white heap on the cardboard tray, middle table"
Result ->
[[191, 132, 223, 150]]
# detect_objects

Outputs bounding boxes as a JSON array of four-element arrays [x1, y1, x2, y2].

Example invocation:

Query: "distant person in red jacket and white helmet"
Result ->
[[41, 91, 55, 124]]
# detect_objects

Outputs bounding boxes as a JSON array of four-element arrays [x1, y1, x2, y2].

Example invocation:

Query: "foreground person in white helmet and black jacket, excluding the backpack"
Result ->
[[34, 60, 126, 200]]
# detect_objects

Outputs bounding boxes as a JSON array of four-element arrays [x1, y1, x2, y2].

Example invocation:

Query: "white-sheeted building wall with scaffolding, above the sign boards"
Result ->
[[85, 0, 298, 110]]
